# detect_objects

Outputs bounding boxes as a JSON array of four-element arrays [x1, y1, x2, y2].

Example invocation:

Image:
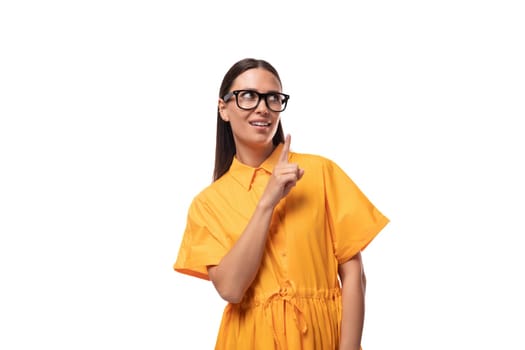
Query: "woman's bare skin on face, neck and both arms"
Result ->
[[208, 68, 365, 350]]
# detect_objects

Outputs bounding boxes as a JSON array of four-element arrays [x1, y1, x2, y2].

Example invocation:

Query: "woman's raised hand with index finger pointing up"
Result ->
[[261, 135, 304, 207]]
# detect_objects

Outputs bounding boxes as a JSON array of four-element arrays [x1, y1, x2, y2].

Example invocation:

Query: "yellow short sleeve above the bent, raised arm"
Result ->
[[173, 198, 232, 280]]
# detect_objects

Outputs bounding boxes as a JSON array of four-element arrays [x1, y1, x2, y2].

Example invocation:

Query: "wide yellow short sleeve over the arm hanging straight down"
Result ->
[[323, 160, 389, 264]]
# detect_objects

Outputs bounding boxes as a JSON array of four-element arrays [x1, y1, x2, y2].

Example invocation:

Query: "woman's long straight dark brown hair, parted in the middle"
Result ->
[[213, 58, 284, 181]]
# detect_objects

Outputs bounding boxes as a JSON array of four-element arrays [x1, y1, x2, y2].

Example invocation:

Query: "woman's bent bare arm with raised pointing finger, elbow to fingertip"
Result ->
[[208, 135, 304, 303]]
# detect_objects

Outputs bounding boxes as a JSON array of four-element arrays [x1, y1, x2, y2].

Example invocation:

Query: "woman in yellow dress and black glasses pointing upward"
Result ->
[[174, 58, 388, 350]]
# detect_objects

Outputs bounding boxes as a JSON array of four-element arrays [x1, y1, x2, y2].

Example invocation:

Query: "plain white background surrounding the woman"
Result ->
[[0, 0, 525, 350]]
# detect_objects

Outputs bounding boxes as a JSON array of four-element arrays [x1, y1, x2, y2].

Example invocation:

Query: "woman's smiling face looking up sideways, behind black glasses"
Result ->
[[219, 68, 281, 150]]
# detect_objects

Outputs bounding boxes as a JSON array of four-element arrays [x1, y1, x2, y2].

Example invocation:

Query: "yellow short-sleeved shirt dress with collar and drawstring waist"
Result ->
[[174, 144, 389, 350]]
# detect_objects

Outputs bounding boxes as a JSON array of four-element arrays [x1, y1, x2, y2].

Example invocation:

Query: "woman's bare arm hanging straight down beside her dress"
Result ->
[[339, 253, 366, 350]]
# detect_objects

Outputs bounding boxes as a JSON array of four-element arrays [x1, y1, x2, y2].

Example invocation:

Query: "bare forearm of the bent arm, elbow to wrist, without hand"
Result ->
[[208, 204, 273, 303]]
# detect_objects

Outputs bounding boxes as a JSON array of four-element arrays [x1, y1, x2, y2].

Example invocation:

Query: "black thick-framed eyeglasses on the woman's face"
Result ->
[[223, 90, 290, 112]]
